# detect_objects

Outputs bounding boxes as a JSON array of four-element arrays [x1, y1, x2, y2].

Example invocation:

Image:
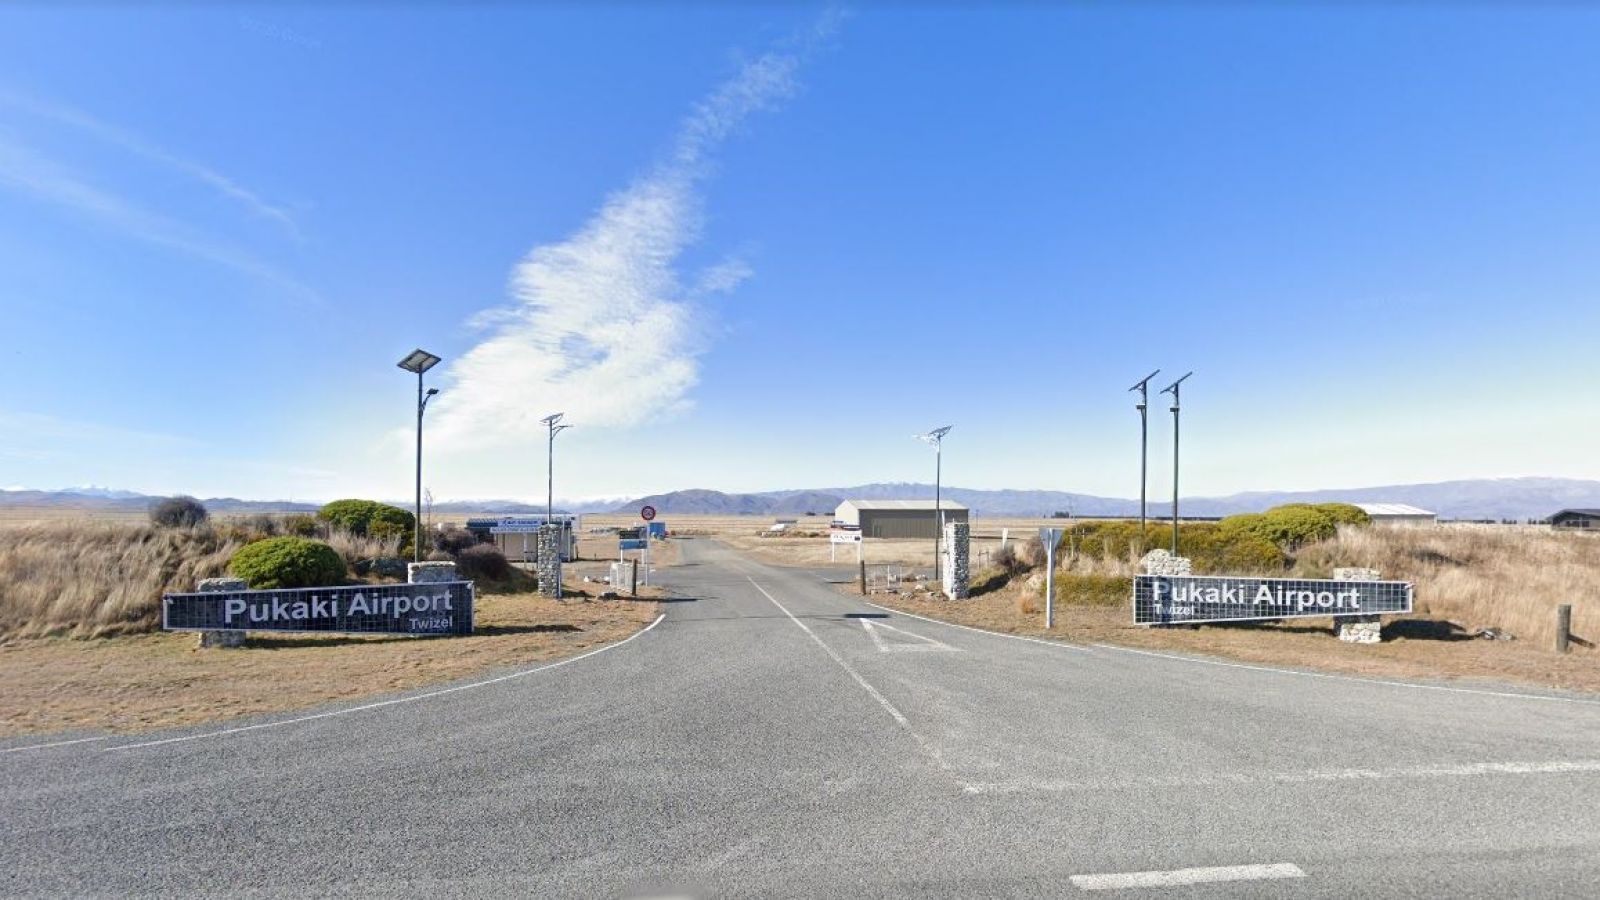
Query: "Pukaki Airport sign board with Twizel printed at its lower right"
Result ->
[[162, 581, 475, 634]]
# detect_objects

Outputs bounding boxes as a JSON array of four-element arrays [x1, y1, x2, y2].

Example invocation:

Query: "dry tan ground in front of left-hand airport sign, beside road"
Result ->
[[0, 583, 661, 737]]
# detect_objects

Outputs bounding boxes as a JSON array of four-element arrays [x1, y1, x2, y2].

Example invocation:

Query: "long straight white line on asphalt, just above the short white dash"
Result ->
[[962, 759, 1600, 794]]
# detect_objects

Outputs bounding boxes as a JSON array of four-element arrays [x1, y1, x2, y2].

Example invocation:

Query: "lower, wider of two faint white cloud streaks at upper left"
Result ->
[[0, 138, 315, 298]]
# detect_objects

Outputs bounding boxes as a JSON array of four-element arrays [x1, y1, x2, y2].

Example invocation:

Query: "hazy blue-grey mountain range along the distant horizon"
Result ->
[[0, 477, 1600, 520]]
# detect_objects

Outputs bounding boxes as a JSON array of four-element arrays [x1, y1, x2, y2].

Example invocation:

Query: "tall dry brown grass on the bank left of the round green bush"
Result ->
[[0, 520, 243, 637]]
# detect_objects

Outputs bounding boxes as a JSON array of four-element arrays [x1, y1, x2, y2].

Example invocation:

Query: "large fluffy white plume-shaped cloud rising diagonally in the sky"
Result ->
[[430, 14, 837, 452]]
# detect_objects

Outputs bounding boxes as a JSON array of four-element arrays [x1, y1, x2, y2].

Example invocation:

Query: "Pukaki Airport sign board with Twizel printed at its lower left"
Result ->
[[1133, 575, 1411, 625]]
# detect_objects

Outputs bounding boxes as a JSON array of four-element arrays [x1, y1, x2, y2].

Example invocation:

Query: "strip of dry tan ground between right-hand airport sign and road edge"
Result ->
[[864, 585, 1600, 692]]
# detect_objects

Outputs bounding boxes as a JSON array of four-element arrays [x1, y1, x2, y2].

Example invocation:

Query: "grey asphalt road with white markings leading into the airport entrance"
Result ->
[[0, 541, 1600, 897]]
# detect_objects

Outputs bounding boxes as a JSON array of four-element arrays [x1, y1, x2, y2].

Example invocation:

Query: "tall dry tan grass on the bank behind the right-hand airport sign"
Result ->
[[1294, 525, 1600, 647]]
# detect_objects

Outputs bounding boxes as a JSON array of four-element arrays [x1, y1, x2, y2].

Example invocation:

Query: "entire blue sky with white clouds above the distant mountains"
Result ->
[[0, 3, 1600, 500]]
